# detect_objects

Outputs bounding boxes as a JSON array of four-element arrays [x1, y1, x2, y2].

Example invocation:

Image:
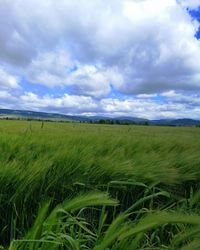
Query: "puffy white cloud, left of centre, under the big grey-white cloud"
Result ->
[[27, 50, 123, 98]]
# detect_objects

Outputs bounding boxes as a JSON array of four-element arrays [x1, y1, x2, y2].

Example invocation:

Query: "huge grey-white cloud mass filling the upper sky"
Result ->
[[0, 0, 200, 97]]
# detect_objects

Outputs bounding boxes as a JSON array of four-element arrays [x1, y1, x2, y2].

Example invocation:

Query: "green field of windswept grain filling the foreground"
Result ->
[[0, 121, 200, 250]]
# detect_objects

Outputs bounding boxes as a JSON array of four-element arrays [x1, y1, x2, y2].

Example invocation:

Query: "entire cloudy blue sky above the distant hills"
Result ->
[[0, 0, 200, 119]]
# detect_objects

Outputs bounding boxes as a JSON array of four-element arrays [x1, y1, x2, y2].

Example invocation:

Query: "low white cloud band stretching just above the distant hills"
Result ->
[[0, 91, 200, 119]]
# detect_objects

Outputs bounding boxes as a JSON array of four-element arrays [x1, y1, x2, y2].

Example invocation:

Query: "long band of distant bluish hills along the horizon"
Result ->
[[0, 109, 200, 126]]
